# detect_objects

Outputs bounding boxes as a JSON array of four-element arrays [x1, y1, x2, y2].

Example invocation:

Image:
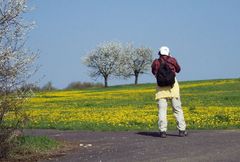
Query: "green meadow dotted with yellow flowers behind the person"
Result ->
[[14, 79, 240, 131]]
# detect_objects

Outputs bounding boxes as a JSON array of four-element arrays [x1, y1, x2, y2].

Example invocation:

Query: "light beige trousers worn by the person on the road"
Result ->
[[158, 98, 186, 132]]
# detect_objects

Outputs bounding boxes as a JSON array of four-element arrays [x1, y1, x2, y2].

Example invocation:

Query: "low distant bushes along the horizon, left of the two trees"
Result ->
[[21, 82, 104, 92]]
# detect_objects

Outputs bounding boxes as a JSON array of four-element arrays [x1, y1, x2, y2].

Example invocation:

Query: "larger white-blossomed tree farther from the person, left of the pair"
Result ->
[[84, 42, 122, 87]]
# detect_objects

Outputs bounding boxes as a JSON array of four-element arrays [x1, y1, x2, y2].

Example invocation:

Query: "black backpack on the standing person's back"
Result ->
[[156, 59, 175, 87]]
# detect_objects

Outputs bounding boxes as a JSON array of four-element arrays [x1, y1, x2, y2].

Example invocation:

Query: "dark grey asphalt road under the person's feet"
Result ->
[[25, 130, 240, 162]]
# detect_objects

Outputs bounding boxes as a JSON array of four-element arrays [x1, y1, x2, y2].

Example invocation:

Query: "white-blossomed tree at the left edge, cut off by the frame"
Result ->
[[0, 0, 37, 156]]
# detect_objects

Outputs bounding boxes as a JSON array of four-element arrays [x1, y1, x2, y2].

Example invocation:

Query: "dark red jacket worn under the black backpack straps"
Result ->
[[152, 55, 181, 75]]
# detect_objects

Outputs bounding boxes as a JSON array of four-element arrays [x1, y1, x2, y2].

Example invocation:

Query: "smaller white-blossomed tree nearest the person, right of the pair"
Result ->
[[118, 44, 152, 84]]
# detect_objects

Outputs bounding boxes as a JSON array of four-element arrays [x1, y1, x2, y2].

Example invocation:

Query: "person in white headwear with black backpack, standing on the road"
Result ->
[[152, 46, 187, 138]]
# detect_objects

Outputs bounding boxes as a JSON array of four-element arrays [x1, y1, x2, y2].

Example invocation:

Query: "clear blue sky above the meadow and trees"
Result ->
[[27, 0, 240, 88]]
